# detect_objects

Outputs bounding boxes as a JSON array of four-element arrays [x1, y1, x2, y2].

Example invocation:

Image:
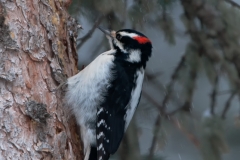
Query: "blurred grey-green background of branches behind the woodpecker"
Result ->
[[69, 0, 240, 160]]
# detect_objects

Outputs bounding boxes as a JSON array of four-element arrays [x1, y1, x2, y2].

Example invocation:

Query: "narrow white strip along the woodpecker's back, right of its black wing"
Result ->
[[125, 68, 144, 131]]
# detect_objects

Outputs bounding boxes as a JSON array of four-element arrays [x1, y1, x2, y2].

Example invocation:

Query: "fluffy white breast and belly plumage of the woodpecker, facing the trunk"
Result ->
[[66, 50, 116, 150]]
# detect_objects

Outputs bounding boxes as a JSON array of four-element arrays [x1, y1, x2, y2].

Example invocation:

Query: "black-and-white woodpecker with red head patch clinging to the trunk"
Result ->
[[66, 28, 152, 160]]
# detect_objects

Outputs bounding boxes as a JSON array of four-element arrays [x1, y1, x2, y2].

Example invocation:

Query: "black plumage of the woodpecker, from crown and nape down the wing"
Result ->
[[96, 30, 152, 160]]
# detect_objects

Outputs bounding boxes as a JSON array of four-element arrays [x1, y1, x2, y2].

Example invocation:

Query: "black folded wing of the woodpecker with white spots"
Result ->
[[96, 64, 135, 160]]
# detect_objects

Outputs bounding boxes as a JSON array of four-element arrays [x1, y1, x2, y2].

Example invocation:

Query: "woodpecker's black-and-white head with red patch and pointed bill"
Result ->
[[100, 28, 152, 68]]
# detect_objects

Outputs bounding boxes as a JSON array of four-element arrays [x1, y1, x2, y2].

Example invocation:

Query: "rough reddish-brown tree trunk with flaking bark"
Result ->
[[0, 0, 82, 160]]
